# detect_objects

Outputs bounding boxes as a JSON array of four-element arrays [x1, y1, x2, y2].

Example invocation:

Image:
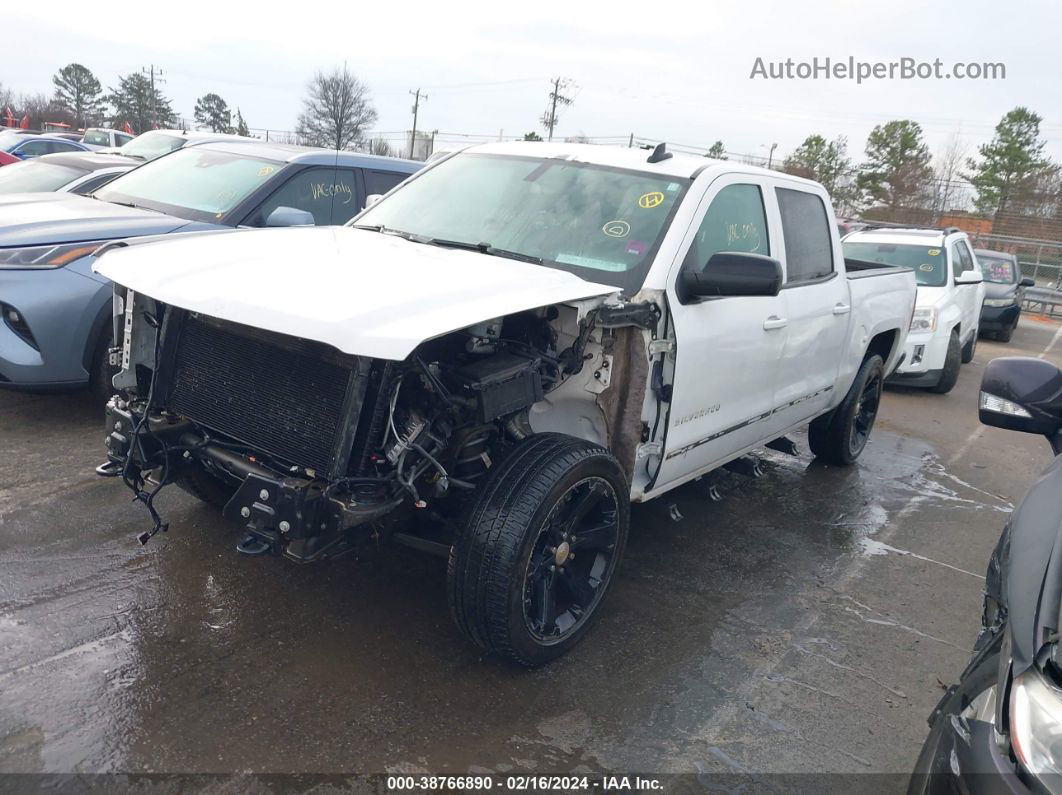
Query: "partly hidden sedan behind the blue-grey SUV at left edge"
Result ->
[[0, 152, 140, 195]]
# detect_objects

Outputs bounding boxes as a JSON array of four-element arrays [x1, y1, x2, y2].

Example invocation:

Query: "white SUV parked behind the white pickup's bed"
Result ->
[[843, 226, 984, 394]]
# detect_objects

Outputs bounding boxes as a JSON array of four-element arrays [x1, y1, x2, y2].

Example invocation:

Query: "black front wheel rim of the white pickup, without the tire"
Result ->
[[524, 478, 619, 644]]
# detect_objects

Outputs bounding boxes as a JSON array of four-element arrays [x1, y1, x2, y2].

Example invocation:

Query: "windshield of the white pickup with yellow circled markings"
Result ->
[[352, 153, 689, 292]]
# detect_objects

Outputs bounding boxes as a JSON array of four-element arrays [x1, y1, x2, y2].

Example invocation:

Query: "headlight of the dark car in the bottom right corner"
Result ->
[[1010, 671, 1062, 776]]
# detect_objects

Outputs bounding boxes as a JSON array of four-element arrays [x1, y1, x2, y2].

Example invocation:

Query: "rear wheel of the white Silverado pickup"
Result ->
[[807, 353, 885, 466]]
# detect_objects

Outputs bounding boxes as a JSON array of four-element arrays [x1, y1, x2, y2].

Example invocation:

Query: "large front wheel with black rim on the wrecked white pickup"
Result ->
[[447, 433, 630, 668]]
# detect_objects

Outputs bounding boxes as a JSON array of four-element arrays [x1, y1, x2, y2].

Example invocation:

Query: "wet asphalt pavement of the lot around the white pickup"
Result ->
[[0, 314, 1062, 773]]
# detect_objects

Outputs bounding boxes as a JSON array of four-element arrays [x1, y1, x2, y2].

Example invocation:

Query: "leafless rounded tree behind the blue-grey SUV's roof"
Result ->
[[295, 66, 376, 150]]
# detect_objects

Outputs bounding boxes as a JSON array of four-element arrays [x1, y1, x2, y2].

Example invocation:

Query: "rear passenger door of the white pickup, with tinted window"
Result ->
[[771, 179, 852, 428]]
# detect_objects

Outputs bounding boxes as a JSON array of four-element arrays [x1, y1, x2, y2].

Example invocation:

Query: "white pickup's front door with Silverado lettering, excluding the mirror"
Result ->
[[656, 174, 788, 485]]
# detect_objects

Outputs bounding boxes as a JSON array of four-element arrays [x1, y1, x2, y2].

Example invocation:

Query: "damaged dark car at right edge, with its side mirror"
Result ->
[[909, 358, 1062, 794]]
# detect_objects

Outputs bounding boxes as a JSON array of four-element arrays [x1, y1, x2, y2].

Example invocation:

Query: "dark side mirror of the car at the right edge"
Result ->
[[978, 357, 1062, 436]]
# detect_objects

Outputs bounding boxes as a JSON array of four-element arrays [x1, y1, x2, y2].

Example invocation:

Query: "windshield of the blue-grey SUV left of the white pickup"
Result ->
[[93, 146, 284, 223]]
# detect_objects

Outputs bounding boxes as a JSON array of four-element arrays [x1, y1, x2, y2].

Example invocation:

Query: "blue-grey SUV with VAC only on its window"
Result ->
[[0, 141, 421, 395]]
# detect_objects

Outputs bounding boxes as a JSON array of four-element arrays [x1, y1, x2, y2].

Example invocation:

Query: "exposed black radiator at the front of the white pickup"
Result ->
[[165, 314, 360, 474]]
